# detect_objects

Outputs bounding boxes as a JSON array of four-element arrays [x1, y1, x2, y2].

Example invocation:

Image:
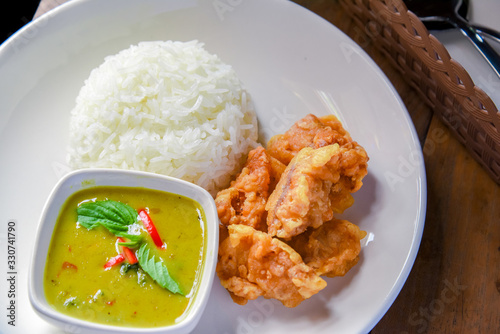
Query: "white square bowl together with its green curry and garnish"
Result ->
[[28, 169, 219, 334]]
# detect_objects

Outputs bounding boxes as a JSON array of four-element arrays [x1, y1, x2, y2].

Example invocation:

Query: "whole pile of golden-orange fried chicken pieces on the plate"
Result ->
[[215, 115, 368, 307]]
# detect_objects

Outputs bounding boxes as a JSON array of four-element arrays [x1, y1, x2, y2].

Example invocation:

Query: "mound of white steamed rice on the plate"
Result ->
[[68, 41, 258, 194]]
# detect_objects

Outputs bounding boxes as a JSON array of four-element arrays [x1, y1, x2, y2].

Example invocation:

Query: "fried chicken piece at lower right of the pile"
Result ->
[[287, 219, 366, 277]]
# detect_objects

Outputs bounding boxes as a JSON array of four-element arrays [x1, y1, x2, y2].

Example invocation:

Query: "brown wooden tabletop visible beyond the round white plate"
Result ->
[[35, 0, 500, 334]]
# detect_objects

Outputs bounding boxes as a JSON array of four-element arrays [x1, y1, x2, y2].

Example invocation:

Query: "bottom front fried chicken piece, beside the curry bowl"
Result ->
[[217, 225, 326, 307]]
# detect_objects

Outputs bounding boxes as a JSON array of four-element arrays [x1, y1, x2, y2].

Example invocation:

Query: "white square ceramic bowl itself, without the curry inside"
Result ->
[[28, 169, 219, 334]]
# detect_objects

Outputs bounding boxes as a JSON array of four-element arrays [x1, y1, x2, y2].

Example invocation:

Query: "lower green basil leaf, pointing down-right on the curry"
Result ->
[[137, 244, 184, 296]]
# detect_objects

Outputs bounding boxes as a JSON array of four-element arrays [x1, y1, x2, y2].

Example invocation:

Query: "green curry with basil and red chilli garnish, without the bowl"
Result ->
[[43, 186, 206, 327]]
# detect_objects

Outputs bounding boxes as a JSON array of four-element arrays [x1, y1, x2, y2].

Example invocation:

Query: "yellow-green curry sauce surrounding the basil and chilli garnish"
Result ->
[[44, 186, 206, 327]]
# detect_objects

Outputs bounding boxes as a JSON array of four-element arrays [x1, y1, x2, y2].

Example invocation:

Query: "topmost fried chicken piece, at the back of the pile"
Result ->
[[266, 114, 358, 165]]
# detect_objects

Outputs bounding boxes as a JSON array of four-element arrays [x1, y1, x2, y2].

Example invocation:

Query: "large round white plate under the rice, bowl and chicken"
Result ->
[[0, 0, 426, 334]]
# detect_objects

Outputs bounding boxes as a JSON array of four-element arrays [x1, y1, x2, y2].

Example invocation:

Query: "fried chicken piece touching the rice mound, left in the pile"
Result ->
[[215, 146, 285, 231]]
